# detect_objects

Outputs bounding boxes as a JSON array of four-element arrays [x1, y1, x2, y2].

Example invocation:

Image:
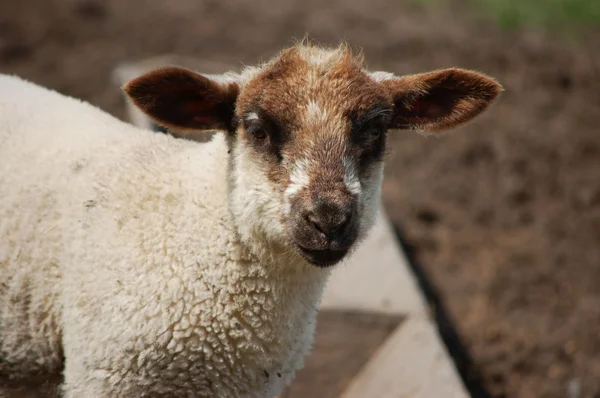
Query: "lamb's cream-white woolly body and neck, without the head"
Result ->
[[0, 75, 328, 397]]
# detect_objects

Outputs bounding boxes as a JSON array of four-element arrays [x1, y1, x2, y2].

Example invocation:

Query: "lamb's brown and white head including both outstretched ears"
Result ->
[[125, 45, 501, 266]]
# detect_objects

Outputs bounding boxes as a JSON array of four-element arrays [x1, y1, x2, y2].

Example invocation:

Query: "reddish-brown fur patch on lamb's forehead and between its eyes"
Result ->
[[236, 45, 392, 190]]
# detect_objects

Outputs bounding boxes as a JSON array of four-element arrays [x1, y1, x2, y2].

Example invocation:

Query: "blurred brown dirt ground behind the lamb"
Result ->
[[0, 0, 600, 398]]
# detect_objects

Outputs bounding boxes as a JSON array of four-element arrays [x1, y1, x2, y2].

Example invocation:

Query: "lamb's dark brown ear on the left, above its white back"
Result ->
[[123, 67, 239, 131]]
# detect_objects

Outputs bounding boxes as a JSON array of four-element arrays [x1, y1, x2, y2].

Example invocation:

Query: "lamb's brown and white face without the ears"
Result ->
[[232, 49, 393, 266]]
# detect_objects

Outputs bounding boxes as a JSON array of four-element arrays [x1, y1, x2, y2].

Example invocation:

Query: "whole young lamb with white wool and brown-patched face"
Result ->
[[0, 44, 501, 398]]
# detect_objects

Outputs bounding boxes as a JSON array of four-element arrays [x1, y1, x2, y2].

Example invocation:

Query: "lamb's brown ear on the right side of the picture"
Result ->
[[381, 68, 502, 132]]
